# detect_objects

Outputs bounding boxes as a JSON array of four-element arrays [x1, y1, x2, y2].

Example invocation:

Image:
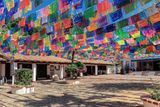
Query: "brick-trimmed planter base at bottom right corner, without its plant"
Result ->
[[141, 96, 160, 107]]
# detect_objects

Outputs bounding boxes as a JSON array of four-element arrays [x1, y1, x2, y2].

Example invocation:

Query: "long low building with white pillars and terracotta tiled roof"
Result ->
[[0, 54, 114, 81]]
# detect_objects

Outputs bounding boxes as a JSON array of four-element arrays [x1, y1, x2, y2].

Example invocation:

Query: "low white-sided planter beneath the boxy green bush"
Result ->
[[11, 86, 34, 94]]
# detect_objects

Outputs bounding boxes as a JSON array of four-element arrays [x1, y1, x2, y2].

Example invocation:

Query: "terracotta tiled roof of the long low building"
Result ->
[[0, 53, 113, 65]]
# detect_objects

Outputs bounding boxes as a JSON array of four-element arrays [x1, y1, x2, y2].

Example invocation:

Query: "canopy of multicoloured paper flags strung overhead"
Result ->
[[0, 0, 160, 61]]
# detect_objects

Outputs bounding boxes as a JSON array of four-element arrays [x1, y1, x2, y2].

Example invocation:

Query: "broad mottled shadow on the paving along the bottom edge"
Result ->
[[18, 94, 142, 107]]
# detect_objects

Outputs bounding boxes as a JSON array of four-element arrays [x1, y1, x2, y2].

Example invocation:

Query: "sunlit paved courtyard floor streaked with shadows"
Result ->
[[0, 75, 159, 107]]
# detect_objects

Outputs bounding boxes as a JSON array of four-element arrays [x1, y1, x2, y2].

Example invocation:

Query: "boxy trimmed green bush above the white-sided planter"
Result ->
[[15, 69, 32, 86]]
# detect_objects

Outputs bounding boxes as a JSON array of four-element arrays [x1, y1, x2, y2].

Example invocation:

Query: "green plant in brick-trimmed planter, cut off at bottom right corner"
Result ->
[[141, 82, 160, 107]]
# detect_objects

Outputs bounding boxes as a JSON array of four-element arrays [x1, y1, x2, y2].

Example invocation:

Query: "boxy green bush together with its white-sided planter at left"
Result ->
[[11, 69, 34, 94]]
